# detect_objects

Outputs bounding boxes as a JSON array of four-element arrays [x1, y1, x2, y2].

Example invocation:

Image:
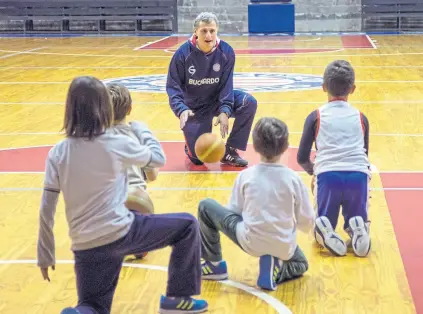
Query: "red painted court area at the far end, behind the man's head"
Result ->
[[139, 35, 374, 55]]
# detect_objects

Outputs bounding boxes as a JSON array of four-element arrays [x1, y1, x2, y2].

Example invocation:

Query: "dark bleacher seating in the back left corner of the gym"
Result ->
[[0, 0, 178, 33]]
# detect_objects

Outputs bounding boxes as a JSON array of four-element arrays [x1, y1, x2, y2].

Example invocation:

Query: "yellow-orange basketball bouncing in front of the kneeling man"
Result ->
[[195, 133, 226, 163]]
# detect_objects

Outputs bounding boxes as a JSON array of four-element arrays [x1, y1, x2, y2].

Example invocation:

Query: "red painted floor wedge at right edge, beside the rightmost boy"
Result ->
[[381, 173, 423, 314]]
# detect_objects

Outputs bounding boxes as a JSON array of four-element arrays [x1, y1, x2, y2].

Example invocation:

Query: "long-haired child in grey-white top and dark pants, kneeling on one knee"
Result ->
[[37, 76, 208, 314]]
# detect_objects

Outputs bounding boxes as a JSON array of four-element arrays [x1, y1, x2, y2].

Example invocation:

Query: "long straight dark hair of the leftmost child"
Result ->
[[63, 76, 113, 139]]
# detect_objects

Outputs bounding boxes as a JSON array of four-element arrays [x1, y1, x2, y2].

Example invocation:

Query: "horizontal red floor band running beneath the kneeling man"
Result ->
[[0, 142, 314, 172]]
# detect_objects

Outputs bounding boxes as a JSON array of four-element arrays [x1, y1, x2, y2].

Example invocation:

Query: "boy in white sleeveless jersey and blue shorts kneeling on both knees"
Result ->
[[297, 60, 371, 257]]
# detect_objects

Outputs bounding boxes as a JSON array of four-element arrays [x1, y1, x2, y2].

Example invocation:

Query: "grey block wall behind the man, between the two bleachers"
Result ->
[[178, 0, 361, 33]]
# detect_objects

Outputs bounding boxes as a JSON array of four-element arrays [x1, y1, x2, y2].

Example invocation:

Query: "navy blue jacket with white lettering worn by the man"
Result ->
[[166, 35, 235, 117]]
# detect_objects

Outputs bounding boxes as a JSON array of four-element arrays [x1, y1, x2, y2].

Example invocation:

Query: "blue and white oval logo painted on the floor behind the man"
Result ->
[[103, 72, 323, 93]]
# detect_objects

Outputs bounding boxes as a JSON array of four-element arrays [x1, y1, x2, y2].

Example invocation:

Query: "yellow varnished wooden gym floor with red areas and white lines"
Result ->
[[0, 35, 423, 314]]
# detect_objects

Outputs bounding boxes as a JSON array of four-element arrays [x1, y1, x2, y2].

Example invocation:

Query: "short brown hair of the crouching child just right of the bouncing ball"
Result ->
[[253, 117, 289, 159]]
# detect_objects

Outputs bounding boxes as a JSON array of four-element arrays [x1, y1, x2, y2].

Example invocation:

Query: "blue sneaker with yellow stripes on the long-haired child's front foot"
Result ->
[[159, 295, 209, 314]]
